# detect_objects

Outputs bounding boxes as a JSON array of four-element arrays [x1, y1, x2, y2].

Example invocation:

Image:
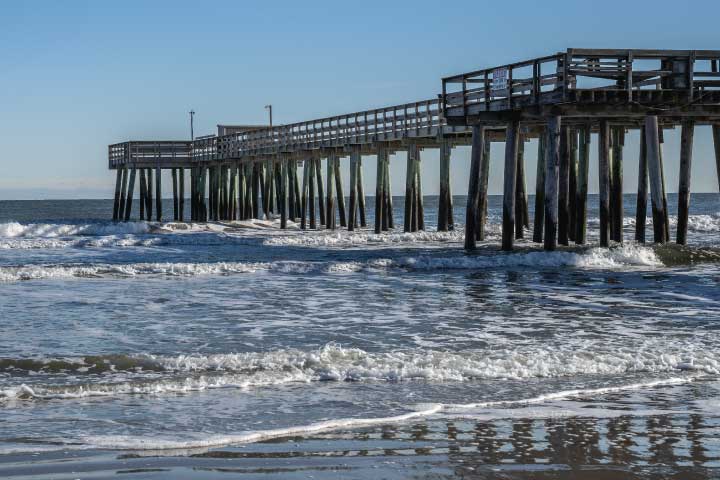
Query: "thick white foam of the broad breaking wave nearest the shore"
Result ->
[[0, 341, 720, 406]]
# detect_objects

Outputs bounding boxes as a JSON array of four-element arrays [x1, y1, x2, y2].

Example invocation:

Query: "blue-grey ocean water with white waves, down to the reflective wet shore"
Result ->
[[0, 194, 720, 478]]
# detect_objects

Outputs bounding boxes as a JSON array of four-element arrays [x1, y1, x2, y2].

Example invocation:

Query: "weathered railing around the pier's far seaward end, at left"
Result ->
[[108, 140, 192, 168]]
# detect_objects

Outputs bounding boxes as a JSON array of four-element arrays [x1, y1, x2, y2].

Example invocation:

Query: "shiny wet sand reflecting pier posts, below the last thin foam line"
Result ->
[[0, 414, 720, 480]]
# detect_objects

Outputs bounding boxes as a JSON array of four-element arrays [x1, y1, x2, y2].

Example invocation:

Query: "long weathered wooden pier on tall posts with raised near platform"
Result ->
[[108, 49, 720, 250]]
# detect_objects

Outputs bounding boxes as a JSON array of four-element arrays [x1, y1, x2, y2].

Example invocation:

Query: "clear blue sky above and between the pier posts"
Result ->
[[0, 0, 720, 199]]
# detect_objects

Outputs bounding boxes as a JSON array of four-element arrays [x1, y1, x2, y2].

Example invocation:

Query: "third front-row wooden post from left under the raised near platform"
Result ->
[[544, 117, 562, 251]]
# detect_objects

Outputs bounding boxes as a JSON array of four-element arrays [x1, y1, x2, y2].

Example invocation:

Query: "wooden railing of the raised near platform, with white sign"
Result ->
[[442, 49, 720, 118]]
